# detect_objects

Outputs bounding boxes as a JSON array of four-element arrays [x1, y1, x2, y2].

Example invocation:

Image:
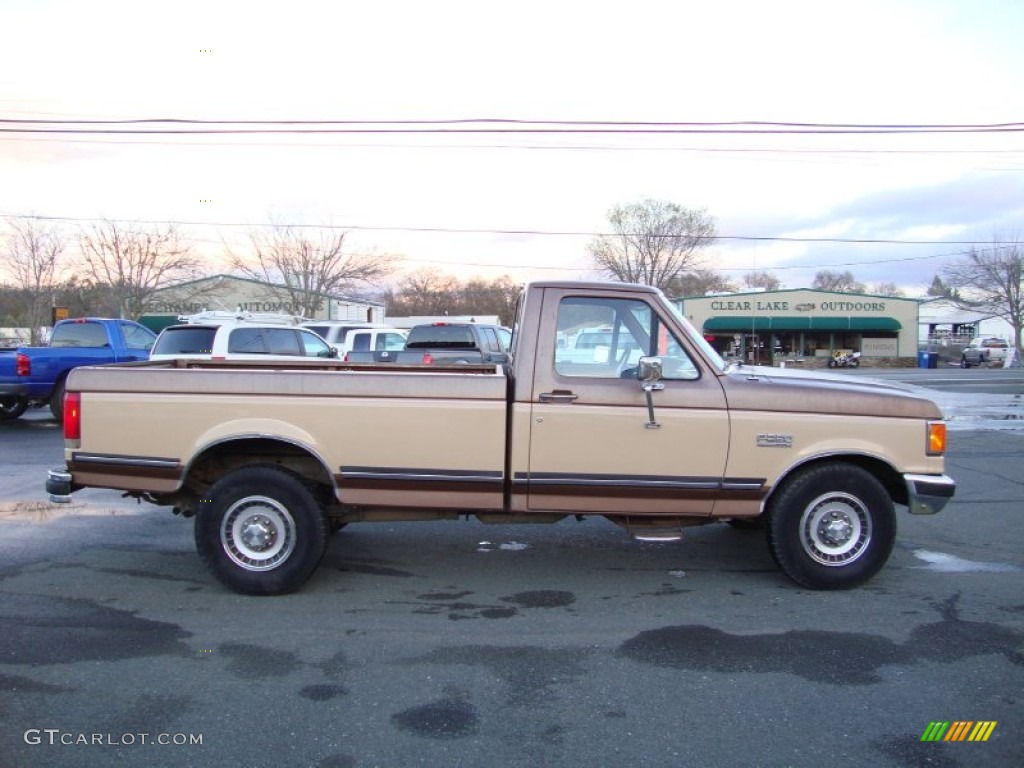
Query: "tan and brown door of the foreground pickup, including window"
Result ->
[[514, 290, 729, 515]]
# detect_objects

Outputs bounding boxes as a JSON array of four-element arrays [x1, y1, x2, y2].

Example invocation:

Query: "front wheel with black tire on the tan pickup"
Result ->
[[768, 462, 896, 590]]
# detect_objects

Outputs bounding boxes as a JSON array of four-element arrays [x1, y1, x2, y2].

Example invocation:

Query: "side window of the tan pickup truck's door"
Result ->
[[555, 297, 699, 380]]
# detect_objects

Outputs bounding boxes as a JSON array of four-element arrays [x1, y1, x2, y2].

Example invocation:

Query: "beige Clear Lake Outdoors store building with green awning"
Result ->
[[676, 289, 921, 367]]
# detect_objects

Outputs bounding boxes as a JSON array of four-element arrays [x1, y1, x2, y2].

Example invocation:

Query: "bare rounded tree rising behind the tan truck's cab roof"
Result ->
[[587, 200, 716, 290]]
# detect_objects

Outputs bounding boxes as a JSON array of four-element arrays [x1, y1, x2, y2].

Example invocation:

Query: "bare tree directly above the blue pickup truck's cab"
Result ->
[[79, 221, 200, 318]]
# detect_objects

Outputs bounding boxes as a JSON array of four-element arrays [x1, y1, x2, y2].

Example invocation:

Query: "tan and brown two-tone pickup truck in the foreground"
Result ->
[[46, 282, 954, 594]]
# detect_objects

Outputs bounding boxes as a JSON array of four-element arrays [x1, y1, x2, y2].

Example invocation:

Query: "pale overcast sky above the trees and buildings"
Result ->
[[0, 0, 1024, 294]]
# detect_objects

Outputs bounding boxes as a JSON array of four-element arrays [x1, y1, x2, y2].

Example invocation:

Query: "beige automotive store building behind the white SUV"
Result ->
[[139, 274, 385, 330]]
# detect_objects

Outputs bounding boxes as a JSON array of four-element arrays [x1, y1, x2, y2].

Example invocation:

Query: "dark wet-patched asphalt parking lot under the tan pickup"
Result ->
[[0, 371, 1024, 768]]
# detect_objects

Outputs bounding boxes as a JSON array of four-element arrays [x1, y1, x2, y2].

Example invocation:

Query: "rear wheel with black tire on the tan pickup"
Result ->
[[195, 465, 328, 595]]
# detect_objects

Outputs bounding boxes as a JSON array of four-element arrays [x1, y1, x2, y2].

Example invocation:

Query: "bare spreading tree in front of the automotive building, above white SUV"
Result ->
[[228, 225, 395, 317]]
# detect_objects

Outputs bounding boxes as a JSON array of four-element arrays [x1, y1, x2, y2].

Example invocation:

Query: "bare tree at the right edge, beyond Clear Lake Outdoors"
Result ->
[[943, 236, 1024, 366]]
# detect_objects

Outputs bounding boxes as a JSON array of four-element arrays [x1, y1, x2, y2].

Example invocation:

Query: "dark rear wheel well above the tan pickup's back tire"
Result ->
[[185, 437, 334, 503]]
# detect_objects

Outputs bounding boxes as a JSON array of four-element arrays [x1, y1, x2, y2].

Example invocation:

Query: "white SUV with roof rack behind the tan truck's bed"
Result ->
[[150, 312, 338, 360]]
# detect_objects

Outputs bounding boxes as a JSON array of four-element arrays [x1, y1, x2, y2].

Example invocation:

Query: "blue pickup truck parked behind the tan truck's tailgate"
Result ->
[[0, 317, 157, 421]]
